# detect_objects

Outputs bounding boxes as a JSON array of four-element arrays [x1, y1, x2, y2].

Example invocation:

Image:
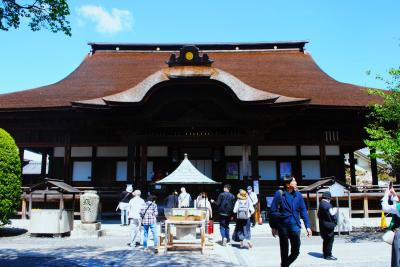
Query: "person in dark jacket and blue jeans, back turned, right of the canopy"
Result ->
[[211, 184, 235, 246]]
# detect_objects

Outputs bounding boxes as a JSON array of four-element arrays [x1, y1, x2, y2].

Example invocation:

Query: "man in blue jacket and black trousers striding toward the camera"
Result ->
[[269, 176, 312, 267]]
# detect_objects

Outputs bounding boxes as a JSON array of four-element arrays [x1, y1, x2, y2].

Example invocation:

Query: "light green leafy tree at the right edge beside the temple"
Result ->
[[364, 69, 400, 183]]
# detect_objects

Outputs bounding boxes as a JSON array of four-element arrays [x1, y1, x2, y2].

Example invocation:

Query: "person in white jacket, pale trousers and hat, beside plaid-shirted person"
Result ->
[[128, 190, 144, 247]]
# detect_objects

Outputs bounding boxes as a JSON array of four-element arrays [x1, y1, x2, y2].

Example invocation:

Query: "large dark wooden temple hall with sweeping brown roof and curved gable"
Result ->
[[0, 41, 377, 197]]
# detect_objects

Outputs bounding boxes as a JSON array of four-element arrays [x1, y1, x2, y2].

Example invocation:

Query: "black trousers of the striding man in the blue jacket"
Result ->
[[278, 227, 301, 267]]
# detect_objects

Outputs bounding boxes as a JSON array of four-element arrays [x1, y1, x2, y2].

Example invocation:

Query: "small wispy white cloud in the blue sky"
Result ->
[[78, 5, 133, 34]]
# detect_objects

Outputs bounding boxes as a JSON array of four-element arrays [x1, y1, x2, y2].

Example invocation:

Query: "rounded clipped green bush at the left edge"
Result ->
[[0, 128, 21, 226]]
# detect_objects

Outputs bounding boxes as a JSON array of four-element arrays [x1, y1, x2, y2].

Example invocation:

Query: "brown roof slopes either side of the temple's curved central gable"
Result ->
[[0, 43, 378, 109]]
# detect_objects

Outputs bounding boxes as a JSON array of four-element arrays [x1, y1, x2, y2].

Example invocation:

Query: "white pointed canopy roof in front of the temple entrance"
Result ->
[[156, 154, 219, 184]]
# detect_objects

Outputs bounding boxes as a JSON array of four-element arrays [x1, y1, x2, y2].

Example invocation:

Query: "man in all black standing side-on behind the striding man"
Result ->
[[318, 191, 337, 260]]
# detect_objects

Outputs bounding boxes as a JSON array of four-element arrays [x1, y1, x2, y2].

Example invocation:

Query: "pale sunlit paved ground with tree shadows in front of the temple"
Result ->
[[0, 223, 390, 267]]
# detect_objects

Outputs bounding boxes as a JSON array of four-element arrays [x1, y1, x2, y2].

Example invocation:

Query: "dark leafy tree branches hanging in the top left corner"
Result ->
[[0, 0, 71, 36]]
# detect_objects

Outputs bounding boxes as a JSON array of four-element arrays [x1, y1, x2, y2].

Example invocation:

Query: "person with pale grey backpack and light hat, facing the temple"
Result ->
[[232, 189, 255, 248]]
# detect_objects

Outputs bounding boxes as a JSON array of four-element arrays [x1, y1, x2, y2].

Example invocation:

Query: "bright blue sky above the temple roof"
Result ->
[[0, 0, 400, 93]]
